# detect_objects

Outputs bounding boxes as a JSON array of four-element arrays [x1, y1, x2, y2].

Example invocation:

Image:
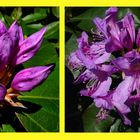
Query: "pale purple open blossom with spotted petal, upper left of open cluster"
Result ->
[[77, 32, 110, 69]]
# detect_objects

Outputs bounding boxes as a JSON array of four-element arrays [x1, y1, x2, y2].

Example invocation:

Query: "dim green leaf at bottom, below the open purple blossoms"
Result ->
[[83, 104, 113, 132]]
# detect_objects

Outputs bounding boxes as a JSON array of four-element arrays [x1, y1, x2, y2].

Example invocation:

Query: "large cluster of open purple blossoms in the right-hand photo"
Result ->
[[68, 7, 140, 125]]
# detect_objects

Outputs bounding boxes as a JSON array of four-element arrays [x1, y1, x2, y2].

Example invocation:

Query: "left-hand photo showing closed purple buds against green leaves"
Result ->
[[0, 7, 59, 132]]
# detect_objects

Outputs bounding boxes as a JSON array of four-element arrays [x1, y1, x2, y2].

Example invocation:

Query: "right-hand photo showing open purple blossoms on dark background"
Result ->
[[65, 7, 140, 132]]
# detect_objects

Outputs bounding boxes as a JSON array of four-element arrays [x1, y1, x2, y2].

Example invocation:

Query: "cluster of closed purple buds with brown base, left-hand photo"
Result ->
[[0, 21, 53, 107]]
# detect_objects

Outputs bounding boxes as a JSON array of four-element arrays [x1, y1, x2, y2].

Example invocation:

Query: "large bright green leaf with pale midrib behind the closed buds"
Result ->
[[16, 41, 59, 132]]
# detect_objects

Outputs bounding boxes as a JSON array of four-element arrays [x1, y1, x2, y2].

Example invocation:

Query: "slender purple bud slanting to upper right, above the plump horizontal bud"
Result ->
[[14, 27, 47, 65]]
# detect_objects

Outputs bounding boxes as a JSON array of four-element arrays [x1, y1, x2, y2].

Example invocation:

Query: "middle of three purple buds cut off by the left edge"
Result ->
[[0, 33, 13, 70]]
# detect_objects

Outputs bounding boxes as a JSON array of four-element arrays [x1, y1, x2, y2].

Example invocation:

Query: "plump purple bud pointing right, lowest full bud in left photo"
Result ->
[[11, 65, 53, 91]]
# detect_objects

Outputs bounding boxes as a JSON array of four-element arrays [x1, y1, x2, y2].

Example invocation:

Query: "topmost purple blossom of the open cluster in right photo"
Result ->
[[93, 7, 135, 52]]
